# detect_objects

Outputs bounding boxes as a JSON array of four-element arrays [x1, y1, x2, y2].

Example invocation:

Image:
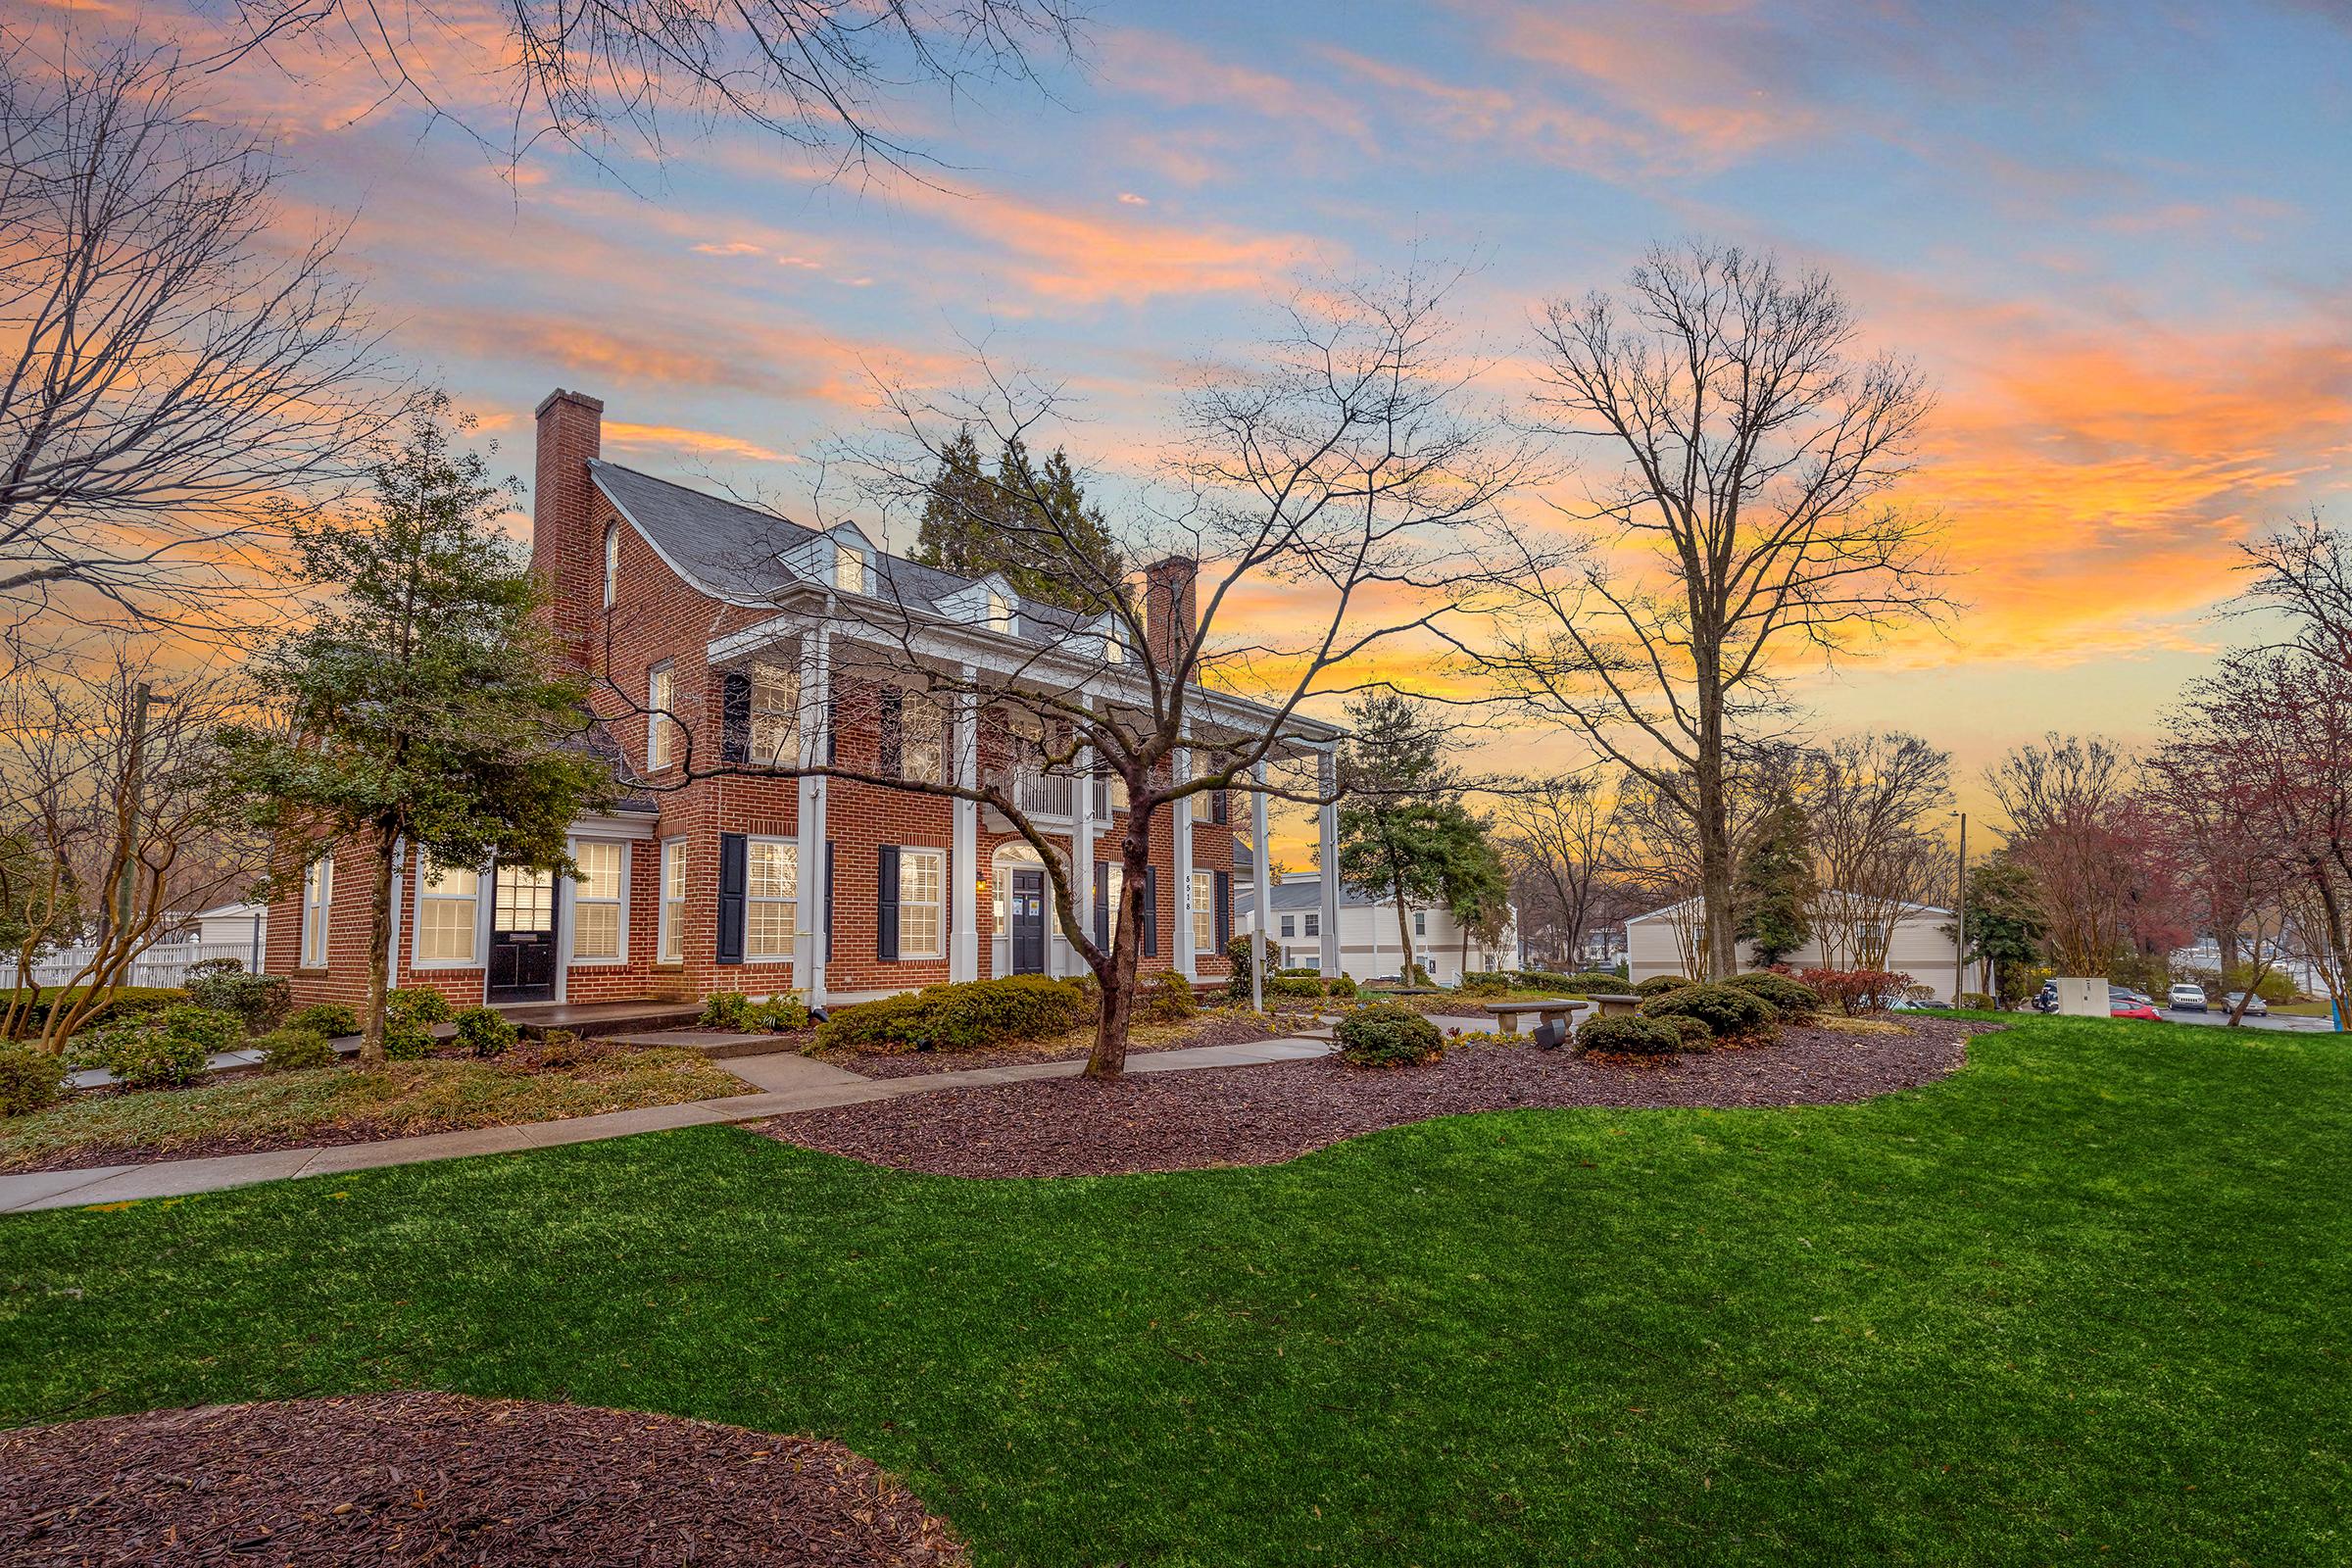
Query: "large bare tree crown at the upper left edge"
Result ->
[[0, 37, 398, 676]]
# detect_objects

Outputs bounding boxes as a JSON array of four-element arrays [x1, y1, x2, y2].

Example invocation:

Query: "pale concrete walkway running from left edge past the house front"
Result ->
[[0, 1039, 1331, 1213]]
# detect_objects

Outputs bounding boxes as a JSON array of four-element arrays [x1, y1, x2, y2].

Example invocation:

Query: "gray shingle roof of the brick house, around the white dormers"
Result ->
[[588, 459, 1089, 642]]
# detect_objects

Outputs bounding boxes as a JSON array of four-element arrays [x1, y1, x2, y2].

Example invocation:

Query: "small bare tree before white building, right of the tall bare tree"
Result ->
[[1804, 731, 1952, 968]]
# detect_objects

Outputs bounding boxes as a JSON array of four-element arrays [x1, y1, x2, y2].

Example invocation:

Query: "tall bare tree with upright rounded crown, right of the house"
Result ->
[[1475, 244, 1945, 976]]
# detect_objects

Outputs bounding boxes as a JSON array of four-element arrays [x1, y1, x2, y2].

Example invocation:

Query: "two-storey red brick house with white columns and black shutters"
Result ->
[[269, 390, 1339, 1006]]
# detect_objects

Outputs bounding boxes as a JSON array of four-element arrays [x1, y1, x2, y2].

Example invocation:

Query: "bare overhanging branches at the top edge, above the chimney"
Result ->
[[216, 0, 1084, 172]]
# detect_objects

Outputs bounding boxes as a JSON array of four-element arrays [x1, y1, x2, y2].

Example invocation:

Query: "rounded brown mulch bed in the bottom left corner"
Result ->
[[0, 1394, 969, 1568]]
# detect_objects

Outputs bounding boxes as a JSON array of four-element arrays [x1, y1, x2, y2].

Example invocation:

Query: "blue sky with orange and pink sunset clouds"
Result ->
[[41, 0, 2352, 827]]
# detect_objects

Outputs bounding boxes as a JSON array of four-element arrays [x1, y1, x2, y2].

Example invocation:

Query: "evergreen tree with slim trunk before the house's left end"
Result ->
[[221, 395, 613, 1067]]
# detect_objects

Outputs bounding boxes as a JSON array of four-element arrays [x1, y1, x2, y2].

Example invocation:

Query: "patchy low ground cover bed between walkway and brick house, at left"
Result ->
[[0, 1034, 748, 1171]]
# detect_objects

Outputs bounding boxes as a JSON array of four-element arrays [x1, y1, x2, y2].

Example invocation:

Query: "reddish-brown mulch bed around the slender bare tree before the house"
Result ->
[[753, 1018, 1987, 1175]]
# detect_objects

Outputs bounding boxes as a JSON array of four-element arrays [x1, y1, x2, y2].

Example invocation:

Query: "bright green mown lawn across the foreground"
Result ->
[[0, 1018, 2352, 1568]]
